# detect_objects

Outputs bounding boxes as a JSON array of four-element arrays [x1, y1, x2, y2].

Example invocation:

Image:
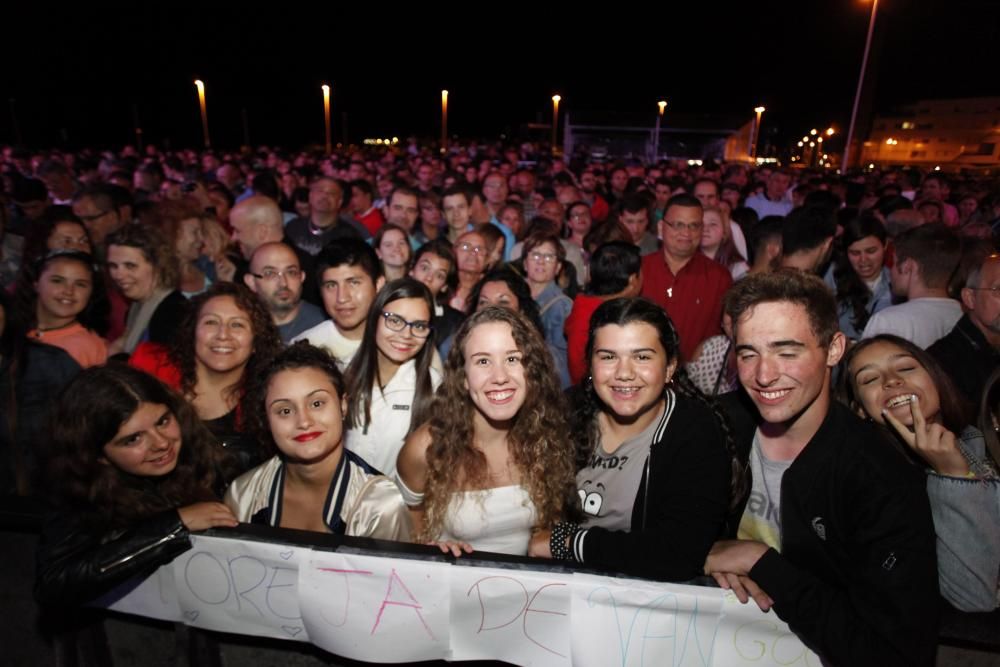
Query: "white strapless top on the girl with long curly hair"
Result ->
[[440, 484, 536, 556]]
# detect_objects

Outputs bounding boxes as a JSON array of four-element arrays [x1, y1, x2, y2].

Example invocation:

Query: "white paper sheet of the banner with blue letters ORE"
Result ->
[[173, 535, 311, 641]]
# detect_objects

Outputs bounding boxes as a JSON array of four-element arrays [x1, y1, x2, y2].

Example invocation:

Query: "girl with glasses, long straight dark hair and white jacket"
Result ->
[[345, 278, 441, 477]]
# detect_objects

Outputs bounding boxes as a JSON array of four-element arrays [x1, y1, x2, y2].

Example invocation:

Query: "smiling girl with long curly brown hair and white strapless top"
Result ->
[[397, 306, 575, 555]]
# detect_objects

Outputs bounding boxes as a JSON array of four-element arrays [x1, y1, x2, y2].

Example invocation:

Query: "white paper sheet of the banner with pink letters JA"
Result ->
[[299, 551, 451, 662]]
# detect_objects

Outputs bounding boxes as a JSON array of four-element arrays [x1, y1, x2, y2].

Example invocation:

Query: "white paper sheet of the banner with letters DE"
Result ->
[[451, 567, 572, 666]]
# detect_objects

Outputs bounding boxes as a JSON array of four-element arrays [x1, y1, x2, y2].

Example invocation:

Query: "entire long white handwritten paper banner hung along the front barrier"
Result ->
[[99, 536, 821, 667]]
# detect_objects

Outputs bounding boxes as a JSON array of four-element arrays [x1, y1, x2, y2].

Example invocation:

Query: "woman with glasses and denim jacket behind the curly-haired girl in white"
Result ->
[[524, 233, 573, 388]]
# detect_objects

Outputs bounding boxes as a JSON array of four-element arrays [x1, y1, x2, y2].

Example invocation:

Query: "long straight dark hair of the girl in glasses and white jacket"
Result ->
[[346, 277, 434, 428]]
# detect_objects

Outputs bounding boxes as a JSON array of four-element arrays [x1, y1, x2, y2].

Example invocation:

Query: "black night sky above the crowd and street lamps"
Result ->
[[0, 0, 1000, 147]]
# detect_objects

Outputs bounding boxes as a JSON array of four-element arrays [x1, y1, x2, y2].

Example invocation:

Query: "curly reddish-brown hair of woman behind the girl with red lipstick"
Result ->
[[167, 282, 282, 412]]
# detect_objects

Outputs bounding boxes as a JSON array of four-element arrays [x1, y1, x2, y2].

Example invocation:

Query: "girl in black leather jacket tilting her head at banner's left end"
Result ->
[[35, 363, 236, 605]]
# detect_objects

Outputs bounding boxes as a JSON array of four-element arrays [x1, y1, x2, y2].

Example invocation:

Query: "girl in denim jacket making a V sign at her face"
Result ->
[[842, 334, 1000, 611]]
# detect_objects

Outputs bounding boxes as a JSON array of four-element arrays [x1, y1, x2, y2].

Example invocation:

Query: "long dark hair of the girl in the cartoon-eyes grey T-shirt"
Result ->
[[570, 298, 747, 508]]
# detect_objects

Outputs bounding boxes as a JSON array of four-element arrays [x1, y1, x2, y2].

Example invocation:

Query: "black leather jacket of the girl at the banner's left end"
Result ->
[[35, 510, 191, 606]]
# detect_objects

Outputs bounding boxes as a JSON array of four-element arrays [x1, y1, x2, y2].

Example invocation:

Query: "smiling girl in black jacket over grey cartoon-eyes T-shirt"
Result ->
[[530, 298, 743, 581]]
